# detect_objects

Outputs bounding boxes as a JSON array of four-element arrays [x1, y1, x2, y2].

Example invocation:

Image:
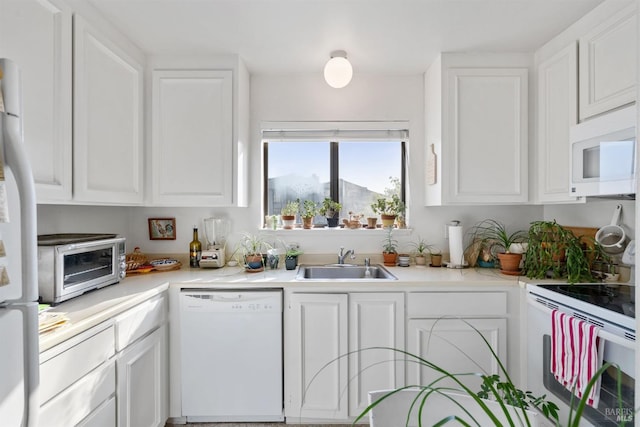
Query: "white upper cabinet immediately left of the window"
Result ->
[[147, 55, 249, 207]]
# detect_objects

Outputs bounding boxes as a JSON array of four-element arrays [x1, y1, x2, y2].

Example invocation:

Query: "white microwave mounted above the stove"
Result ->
[[569, 105, 637, 197]]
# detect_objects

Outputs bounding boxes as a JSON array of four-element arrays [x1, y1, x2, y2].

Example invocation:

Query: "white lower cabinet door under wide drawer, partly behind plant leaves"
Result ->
[[407, 318, 507, 390]]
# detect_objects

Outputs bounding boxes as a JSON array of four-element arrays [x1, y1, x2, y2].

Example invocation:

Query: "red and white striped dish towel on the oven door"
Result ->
[[551, 310, 604, 407]]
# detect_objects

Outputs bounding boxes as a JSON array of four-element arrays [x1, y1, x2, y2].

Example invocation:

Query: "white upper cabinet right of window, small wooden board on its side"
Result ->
[[425, 54, 530, 206]]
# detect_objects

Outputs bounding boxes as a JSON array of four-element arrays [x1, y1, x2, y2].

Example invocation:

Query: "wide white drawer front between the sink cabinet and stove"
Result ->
[[407, 292, 507, 318]]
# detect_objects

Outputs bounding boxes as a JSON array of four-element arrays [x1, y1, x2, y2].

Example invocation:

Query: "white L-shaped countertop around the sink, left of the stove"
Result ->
[[40, 265, 521, 352]]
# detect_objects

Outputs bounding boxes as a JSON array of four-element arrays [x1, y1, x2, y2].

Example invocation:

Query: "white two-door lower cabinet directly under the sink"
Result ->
[[285, 292, 404, 422]]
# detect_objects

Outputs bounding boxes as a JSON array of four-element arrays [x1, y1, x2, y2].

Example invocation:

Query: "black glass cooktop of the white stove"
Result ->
[[538, 283, 636, 317]]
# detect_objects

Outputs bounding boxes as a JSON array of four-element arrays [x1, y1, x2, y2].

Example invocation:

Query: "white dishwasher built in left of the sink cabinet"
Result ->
[[180, 289, 284, 422]]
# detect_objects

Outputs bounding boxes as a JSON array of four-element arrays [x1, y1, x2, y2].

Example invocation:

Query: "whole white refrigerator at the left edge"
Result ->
[[0, 58, 39, 426]]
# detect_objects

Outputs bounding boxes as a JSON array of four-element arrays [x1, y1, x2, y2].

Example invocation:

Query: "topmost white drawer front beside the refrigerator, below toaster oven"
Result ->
[[40, 325, 115, 405]]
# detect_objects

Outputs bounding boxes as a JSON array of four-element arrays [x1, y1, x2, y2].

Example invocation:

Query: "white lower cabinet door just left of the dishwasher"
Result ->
[[116, 326, 168, 427]]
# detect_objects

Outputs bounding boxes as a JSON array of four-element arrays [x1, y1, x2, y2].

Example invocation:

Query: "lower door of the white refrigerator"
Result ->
[[0, 303, 39, 426]]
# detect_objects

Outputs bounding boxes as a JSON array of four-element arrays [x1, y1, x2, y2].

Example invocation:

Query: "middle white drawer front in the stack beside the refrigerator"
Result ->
[[40, 360, 116, 427]]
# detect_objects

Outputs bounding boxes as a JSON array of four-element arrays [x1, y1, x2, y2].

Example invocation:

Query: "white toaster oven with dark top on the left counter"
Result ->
[[38, 233, 126, 304]]
